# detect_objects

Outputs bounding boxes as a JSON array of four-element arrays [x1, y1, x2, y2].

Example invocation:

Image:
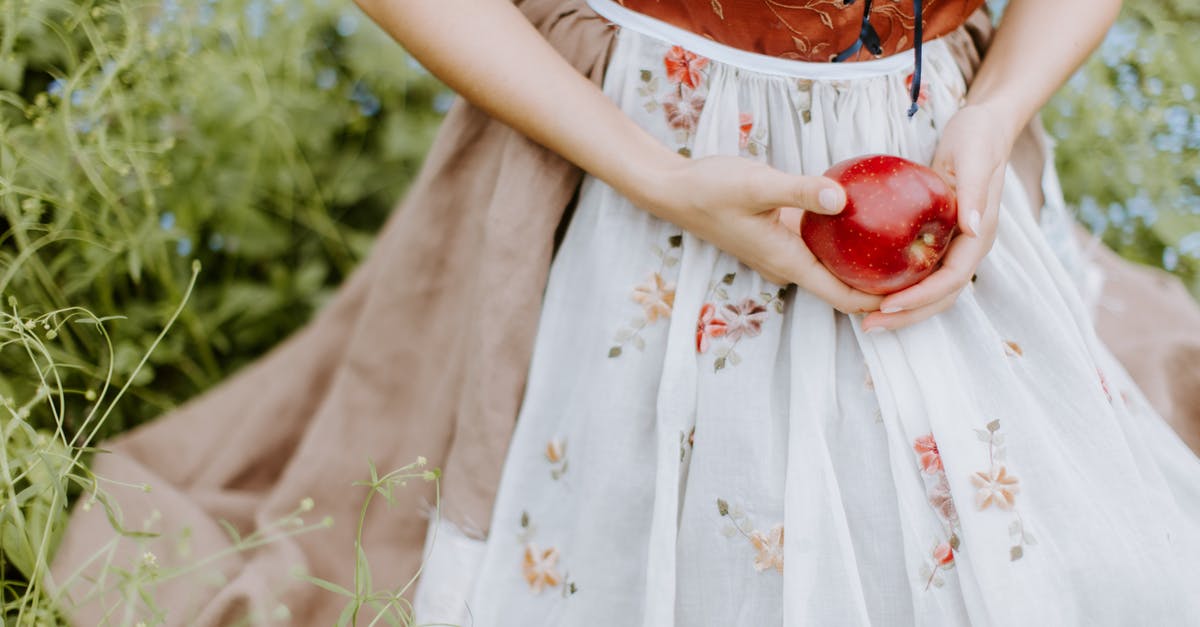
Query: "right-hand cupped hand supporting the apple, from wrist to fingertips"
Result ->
[[863, 105, 1015, 332]]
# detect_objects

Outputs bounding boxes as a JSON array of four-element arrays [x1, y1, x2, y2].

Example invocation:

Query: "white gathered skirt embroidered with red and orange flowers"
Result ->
[[418, 6, 1200, 627]]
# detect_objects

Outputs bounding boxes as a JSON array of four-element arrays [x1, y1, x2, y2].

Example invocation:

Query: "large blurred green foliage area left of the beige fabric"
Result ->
[[0, 0, 446, 444]]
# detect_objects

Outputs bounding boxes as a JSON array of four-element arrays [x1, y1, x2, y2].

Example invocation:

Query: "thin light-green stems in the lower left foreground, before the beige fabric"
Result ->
[[0, 275, 440, 627]]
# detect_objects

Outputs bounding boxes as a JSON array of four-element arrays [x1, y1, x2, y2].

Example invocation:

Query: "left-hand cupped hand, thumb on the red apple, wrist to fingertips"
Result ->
[[633, 156, 882, 314]]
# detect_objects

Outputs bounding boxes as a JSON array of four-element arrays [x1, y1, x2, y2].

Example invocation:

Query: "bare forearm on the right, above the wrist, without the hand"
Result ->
[[967, 0, 1121, 137]]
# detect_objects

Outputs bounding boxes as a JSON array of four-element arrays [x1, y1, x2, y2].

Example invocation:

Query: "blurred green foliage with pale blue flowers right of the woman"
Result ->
[[1045, 0, 1200, 295]]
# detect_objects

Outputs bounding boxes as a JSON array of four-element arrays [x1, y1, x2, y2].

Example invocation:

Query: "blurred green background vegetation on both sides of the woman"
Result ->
[[0, 0, 1200, 614]]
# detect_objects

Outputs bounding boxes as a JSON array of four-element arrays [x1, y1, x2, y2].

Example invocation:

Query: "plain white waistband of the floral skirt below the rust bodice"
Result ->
[[587, 0, 944, 80]]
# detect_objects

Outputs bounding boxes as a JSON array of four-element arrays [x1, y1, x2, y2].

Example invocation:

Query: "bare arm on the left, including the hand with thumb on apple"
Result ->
[[356, 0, 880, 311]]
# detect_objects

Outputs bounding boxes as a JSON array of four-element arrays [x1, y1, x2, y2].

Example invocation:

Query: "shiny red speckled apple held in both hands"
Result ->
[[800, 155, 958, 294]]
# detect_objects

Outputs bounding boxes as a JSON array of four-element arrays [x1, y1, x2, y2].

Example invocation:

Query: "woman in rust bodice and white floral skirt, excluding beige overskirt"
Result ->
[[350, 0, 1200, 626]]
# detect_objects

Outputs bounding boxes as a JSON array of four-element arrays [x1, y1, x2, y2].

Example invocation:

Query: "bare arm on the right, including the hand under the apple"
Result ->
[[863, 0, 1121, 329]]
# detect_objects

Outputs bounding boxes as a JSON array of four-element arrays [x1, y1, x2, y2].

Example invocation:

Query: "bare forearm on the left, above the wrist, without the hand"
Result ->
[[355, 0, 684, 204]]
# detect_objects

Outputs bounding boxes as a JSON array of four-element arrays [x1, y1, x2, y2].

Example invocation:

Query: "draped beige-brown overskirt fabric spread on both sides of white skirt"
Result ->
[[52, 0, 1200, 626]]
